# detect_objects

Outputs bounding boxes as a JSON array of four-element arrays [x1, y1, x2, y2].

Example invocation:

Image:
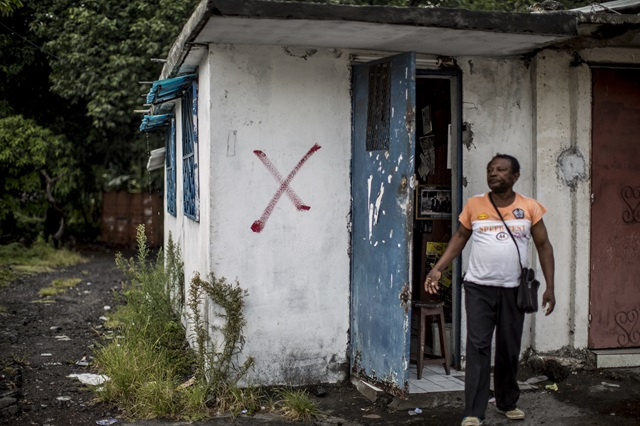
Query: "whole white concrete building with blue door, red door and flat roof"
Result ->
[[145, 0, 640, 393]]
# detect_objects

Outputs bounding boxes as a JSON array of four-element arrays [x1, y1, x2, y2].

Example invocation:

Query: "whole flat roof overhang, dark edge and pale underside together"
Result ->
[[162, 0, 640, 78]]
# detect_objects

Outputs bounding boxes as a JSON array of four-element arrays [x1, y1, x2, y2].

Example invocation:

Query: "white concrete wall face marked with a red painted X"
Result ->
[[202, 45, 351, 384]]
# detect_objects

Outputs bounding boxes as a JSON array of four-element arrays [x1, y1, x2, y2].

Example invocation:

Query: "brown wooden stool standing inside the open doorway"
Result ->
[[413, 301, 451, 380]]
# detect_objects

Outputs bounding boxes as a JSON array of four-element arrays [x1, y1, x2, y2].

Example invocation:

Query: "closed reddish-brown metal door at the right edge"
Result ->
[[589, 68, 640, 349]]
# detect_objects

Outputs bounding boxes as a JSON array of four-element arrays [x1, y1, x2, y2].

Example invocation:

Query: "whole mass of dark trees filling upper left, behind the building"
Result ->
[[0, 0, 197, 243]]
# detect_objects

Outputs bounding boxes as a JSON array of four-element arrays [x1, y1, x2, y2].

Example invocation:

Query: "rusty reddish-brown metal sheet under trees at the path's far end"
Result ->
[[101, 192, 164, 247]]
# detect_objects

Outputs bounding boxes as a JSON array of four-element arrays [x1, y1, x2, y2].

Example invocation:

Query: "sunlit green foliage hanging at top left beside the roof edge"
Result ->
[[32, 0, 195, 132]]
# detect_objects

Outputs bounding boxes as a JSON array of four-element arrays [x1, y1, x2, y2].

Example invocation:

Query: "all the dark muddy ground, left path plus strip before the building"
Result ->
[[0, 247, 640, 426]]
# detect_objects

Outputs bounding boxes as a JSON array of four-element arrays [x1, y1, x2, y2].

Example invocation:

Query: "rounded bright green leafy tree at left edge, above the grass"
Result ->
[[0, 115, 78, 245]]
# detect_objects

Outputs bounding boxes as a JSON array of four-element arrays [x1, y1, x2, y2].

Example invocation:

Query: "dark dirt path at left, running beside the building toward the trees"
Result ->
[[0, 249, 123, 425]]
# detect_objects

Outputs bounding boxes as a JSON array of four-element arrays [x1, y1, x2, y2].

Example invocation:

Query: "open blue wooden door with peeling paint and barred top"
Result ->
[[351, 52, 415, 394]]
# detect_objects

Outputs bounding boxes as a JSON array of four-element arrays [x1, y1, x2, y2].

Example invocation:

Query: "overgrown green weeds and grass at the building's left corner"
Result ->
[[95, 225, 320, 420]]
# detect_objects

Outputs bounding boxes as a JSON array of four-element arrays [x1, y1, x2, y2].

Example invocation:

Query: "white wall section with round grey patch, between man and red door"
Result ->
[[533, 48, 640, 352]]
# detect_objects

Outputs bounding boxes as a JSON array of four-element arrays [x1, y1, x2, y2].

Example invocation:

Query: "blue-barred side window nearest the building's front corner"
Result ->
[[182, 81, 200, 221]]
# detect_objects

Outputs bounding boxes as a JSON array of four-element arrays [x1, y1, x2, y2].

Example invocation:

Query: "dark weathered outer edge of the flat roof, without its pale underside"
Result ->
[[161, 0, 640, 78]]
